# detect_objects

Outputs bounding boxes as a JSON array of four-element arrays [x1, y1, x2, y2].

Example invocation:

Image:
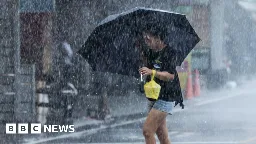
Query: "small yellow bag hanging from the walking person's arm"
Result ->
[[144, 70, 161, 100]]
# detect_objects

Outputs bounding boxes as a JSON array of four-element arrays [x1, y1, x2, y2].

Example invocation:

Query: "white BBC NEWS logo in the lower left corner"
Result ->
[[6, 123, 75, 134]]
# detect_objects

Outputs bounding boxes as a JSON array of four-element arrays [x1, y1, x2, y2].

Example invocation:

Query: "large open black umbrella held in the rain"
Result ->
[[78, 8, 200, 77]]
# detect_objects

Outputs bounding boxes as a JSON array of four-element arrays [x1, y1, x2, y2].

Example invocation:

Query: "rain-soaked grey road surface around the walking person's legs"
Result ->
[[28, 86, 256, 144]]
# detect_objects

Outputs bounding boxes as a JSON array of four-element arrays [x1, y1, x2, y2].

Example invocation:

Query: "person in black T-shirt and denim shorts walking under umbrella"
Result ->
[[139, 28, 184, 144]]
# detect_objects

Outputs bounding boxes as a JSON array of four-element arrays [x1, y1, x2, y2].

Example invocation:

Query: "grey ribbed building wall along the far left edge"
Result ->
[[0, 0, 26, 128]]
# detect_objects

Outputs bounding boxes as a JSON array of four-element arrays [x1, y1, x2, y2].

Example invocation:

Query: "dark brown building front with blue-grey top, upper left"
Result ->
[[20, 0, 54, 80]]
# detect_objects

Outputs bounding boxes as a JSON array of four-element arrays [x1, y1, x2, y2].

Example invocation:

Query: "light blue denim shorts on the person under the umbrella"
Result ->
[[148, 100, 174, 114]]
